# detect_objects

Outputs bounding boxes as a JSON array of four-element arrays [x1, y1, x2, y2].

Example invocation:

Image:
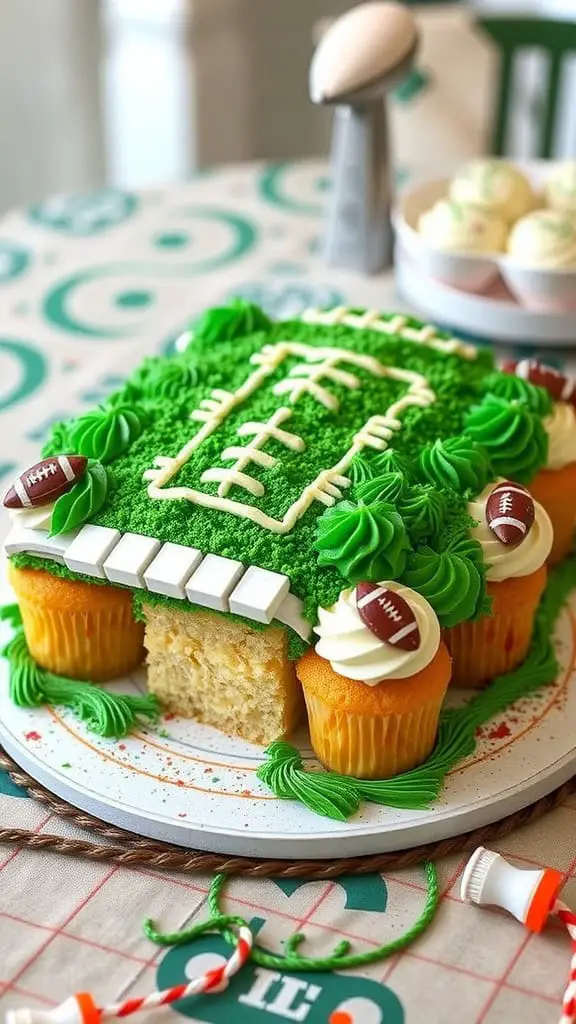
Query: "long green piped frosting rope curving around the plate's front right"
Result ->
[[256, 558, 576, 821]]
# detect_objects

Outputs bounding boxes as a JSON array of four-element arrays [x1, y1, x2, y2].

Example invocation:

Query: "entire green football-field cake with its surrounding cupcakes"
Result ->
[[4, 302, 576, 779]]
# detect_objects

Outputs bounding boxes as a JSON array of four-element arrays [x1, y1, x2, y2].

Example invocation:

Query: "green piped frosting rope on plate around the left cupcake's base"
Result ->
[[0, 605, 160, 739]]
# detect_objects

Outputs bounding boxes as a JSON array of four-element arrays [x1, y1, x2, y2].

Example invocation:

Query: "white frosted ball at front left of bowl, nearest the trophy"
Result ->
[[418, 199, 507, 253]]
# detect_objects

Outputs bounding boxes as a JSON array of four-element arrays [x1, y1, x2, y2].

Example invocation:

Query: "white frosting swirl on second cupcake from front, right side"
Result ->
[[468, 477, 553, 581]]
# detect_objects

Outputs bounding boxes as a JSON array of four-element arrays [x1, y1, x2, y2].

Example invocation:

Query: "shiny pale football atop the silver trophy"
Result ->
[[310, 0, 417, 103]]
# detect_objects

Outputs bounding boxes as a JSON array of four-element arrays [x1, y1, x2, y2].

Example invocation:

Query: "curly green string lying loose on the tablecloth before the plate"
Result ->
[[143, 862, 440, 972]]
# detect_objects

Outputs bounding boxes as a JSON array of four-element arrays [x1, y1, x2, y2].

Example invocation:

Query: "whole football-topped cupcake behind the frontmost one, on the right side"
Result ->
[[444, 480, 553, 689]]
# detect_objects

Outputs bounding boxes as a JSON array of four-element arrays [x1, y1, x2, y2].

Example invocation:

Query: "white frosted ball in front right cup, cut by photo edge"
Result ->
[[508, 210, 576, 268]]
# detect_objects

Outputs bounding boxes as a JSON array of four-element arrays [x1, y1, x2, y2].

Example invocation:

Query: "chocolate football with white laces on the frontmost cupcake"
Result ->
[[356, 583, 420, 650]]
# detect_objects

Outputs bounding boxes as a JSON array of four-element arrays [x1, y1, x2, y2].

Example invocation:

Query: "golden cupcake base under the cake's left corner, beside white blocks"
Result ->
[[9, 564, 145, 682]]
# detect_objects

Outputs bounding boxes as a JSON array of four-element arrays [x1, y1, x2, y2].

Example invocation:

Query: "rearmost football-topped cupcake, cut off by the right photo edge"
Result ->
[[501, 359, 576, 565]]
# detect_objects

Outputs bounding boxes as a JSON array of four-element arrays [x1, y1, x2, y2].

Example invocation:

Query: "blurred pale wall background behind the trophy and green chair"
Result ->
[[0, 0, 576, 212]]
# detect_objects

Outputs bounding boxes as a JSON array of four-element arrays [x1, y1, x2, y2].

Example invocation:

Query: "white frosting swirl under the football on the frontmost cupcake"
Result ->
[[315, 582, 440, 686]]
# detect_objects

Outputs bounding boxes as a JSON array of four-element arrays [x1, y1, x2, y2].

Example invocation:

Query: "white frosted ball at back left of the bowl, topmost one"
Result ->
[[450, 160, 535, 223]]
